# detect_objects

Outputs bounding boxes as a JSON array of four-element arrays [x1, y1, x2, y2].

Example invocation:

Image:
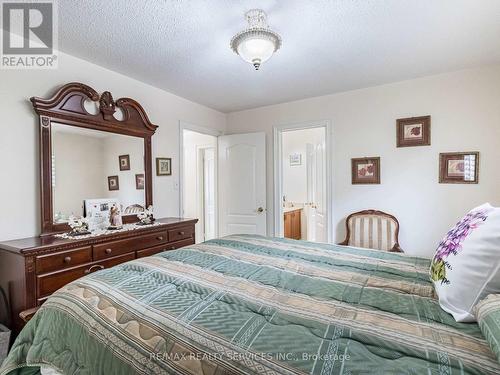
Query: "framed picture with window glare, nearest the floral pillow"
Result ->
[[439, 151, 479, 184]]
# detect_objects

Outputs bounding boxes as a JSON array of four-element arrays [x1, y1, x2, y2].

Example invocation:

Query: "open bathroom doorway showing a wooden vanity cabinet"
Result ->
[[274, 122, 332, 242]]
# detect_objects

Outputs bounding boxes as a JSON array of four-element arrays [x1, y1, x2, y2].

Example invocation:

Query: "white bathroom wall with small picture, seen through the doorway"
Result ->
[[282, 128, 325, 203]]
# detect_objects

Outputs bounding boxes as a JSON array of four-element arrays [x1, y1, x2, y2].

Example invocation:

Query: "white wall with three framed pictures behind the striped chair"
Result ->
[[227, 66, 500, 256]]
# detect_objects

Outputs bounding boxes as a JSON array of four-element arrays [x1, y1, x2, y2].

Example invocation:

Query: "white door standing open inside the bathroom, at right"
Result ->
[[313, 142, 327, 242]]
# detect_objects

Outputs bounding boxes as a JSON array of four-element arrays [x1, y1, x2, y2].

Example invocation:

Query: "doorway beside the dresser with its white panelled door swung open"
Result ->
[[179, 122, 267, 243]]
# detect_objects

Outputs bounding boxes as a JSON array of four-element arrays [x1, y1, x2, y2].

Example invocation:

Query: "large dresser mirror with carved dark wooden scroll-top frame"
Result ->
[[31, 83, 157, 235]]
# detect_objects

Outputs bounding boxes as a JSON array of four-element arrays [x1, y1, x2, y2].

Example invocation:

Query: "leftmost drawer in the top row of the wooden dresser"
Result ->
[[36, 246, 92, 274]]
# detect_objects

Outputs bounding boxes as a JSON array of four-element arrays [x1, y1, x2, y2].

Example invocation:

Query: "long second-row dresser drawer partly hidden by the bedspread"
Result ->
[[37, 253, 135, 301]]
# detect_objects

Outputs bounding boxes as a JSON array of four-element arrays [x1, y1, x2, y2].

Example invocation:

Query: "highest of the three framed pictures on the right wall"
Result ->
[[396, 116, 431, 147]]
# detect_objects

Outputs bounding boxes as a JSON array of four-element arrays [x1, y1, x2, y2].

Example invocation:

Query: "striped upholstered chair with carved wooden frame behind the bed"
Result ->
[[339, 210, 403, 253]]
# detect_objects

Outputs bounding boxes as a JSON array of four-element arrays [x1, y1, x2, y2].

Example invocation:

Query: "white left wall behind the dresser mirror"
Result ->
[[0, 53, 226, 241]]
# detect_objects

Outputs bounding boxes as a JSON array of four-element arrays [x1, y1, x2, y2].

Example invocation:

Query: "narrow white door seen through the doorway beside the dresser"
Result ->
[[203, 148, 217, 241]]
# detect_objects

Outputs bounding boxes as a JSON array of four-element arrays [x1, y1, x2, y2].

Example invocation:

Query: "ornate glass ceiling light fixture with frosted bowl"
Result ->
[[231, 9, 281, 70]]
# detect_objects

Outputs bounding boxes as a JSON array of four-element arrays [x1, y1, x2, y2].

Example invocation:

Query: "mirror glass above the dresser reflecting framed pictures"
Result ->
[[52, 123, 145, 225]]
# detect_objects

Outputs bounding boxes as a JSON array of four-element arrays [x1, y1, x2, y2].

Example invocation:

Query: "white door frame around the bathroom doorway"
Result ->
[[273, 120, 334, 243]]
